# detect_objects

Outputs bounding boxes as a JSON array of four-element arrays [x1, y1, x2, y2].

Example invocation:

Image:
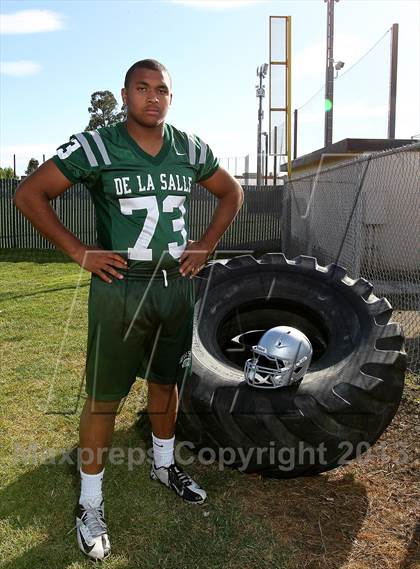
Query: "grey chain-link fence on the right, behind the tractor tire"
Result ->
[[283, 143, 420, 374]]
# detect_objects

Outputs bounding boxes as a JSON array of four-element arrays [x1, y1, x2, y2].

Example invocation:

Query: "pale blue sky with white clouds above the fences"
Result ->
[[0, 0, 420, 174]]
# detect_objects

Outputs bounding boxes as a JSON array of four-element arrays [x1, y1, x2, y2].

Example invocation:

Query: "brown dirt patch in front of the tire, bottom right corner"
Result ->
[[239, 387, 420, 569]]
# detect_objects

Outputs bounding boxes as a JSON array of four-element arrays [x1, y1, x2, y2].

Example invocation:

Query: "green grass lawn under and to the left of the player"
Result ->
[[0, 253, 296, 569]]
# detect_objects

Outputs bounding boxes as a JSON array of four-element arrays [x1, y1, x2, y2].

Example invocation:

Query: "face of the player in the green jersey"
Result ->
[[121, 68, 172, 128]]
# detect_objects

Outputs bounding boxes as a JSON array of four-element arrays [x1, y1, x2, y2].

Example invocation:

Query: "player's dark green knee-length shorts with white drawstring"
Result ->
[[86, 268, 195, 401]]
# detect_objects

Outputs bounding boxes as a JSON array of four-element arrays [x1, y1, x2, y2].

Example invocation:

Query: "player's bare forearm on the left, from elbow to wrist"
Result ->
[[14, 191, 85, 260]]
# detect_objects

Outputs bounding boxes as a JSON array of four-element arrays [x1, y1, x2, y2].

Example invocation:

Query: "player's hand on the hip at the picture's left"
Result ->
[[73, 245, 127, 283]]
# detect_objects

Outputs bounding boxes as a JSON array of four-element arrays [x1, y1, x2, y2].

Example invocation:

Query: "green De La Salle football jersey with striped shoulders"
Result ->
[[53, 119, 219, 268]]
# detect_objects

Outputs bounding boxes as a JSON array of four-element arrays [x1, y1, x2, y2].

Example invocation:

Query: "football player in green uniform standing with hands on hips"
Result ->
[[14, 59, 243, 560]]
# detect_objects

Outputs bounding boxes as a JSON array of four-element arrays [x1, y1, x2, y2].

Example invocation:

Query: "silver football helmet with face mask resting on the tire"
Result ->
[[244, 326, 312, 389]]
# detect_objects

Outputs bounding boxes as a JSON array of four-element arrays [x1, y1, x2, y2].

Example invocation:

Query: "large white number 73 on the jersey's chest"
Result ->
[[119, 196, 187, 261]]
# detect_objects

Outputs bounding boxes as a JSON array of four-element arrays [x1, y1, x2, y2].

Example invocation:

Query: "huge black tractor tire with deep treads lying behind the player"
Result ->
[[177, 253, 406, 478]]
